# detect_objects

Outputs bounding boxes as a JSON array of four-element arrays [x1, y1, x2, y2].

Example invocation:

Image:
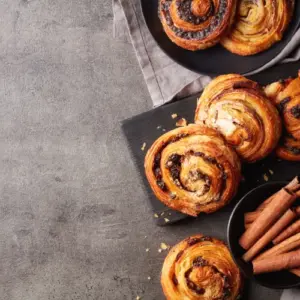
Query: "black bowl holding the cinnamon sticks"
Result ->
[[227, 182, 300, 289]]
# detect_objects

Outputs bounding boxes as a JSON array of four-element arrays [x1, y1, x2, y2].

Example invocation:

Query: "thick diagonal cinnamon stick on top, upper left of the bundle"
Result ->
[[239, 188, 297, 250]]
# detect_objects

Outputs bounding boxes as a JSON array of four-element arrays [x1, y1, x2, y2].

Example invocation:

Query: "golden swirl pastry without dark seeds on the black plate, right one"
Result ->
[[221, 0, 294, 56]]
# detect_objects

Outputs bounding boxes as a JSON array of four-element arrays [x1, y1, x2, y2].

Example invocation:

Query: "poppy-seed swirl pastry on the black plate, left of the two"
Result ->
[[159, 0, 236, 51]]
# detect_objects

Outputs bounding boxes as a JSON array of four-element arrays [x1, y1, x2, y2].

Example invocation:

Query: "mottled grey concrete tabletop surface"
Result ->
[[0, 0, 282, 300]]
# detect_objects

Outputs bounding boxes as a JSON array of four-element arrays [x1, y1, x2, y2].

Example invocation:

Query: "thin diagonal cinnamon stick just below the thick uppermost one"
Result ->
[[243, 209, 297, 261]]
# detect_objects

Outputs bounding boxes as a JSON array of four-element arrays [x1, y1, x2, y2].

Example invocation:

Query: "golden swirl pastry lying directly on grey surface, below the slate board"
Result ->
[[161, 235, 243, 300]]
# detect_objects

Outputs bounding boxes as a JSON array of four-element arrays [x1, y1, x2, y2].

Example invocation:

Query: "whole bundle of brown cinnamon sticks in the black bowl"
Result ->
[[239, 176, 300, 277]]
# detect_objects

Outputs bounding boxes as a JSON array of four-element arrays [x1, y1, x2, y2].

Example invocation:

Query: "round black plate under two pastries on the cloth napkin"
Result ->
[[141, 0, 300, 75]]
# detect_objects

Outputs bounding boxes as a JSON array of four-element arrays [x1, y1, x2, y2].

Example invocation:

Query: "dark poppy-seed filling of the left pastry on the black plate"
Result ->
[[160, 0, 227, 40]]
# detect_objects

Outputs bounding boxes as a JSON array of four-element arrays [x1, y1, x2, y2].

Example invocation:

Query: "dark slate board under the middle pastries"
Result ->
[[122, 63, 300, 226]]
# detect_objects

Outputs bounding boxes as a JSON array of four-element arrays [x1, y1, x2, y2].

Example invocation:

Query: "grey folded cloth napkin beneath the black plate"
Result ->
[[112, 0, 300, 106]]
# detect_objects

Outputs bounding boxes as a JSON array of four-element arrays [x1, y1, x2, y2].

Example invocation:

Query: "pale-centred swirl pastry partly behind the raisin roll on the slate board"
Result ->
[[195, 74, 281, 162]]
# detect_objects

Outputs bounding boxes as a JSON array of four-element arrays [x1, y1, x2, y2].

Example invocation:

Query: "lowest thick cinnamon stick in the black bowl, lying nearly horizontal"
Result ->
[[253, 250, 300, 274]]
